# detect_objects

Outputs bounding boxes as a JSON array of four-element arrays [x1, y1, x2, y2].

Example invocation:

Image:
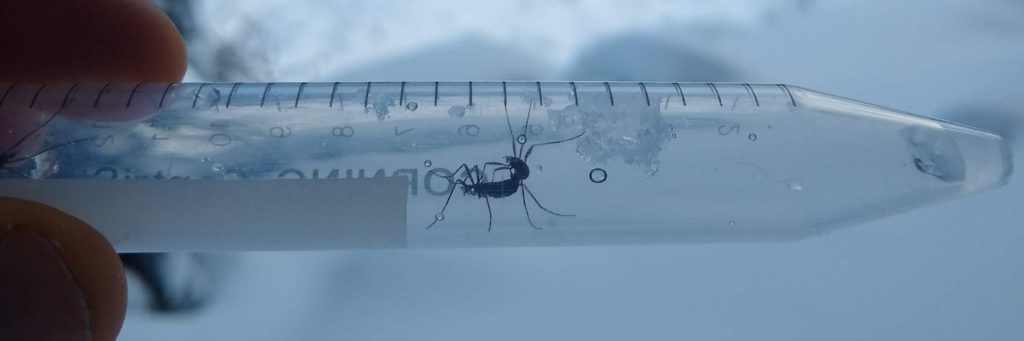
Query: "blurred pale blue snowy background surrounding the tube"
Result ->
[[122, 0, 1024, 340]]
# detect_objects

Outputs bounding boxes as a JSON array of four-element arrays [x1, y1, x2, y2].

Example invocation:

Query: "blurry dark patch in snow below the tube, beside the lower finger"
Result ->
[[121, 253, 210, 312]]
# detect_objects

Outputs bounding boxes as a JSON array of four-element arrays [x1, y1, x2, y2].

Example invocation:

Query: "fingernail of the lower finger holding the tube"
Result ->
[[0, 224, 90, 340]]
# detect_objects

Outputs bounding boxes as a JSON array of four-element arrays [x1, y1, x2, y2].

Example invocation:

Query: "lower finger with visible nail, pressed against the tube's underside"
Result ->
[[0, 198, 126, 340]]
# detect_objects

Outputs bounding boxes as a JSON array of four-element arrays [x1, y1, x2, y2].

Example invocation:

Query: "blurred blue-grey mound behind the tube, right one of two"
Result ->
[[566, 34, 739, 82]]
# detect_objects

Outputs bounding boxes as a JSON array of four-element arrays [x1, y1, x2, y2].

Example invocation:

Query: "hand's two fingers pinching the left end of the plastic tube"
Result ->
[[0, 0, 185, 340]]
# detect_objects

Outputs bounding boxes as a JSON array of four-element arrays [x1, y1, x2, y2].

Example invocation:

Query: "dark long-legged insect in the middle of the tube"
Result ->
[[427, 102, 584, 231]]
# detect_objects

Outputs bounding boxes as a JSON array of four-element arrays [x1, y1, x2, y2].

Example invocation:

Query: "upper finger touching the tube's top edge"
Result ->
[[0, 0, 186, 83]]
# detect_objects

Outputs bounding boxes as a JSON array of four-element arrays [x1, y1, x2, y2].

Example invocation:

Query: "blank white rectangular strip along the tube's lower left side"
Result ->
[[0, 176, 409, 252]]
